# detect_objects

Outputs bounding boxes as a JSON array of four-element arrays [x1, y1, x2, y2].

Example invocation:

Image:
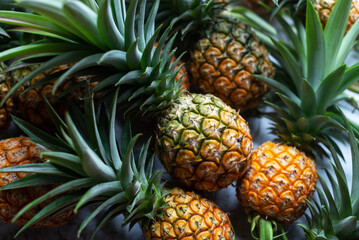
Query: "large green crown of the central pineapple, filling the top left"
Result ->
[[0, 0, 186, 115]]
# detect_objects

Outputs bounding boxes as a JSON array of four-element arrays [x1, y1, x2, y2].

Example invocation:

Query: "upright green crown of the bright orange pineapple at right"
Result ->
[[232, 0, 359, 154]]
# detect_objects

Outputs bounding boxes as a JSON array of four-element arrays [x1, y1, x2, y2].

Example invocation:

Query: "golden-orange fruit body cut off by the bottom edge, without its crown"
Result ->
[[144, 188, 234, 240]]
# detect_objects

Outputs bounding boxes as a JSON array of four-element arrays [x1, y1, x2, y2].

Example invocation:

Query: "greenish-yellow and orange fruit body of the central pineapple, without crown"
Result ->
[[156, 94, 253, 192]]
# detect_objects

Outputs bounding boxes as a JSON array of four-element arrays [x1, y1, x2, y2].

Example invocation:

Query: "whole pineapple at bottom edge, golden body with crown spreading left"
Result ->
[[1, 95, 234, 240]]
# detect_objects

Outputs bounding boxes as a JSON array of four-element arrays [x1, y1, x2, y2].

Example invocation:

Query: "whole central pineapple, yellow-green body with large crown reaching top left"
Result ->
[[0, 0, 252, 192]]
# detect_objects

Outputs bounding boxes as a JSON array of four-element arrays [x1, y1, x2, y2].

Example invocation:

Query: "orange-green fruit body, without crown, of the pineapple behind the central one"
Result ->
[[189, 17, 274, 111]]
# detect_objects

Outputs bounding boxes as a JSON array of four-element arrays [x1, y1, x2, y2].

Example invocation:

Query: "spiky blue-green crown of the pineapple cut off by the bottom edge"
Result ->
[[0, 91, 168, 238]]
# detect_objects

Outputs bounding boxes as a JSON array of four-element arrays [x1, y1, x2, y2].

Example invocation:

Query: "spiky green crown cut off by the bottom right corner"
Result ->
[[299, 110, 359, 240]]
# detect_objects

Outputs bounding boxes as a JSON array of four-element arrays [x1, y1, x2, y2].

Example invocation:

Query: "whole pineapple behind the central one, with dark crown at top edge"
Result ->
[[155, 0, 274, 111]]
